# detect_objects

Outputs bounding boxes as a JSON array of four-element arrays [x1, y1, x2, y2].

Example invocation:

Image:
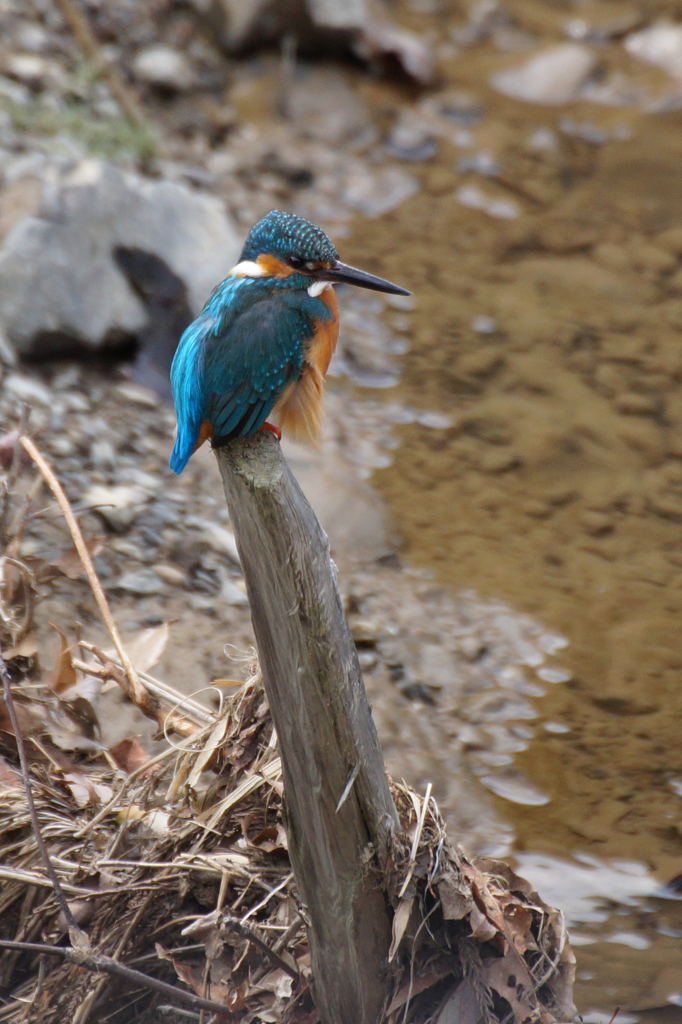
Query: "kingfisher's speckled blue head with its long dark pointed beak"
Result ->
[[232, 210, 412, 295]]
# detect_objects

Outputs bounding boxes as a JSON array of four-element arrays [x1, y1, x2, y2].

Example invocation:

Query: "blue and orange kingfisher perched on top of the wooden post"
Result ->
[[170, 210, 411, 473]]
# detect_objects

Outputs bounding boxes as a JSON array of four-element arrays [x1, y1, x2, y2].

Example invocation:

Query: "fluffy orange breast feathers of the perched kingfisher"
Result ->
[[272, 288, 339, 447]]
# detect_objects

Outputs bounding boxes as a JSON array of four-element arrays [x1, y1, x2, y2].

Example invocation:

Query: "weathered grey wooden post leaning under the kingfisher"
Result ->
[[216, 431, 398, 1024]]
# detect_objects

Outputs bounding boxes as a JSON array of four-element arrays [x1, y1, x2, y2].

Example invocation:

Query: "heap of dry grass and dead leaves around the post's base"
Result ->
[[0, 434, 573, 1024]]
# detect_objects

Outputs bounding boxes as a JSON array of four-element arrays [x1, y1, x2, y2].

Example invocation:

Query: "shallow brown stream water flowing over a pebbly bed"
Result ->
[[343, 0, 682, 1016]]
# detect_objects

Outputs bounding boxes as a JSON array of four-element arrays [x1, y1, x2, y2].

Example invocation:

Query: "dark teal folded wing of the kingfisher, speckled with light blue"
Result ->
[[203, 295, 314, 439]]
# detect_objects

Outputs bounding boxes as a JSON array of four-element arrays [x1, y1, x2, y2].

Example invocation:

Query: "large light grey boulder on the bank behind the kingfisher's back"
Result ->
[[0, 160, 241, 354]]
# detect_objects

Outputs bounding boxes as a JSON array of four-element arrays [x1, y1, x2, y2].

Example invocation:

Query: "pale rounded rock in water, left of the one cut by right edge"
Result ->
[[491, 43, 597, 103]]
